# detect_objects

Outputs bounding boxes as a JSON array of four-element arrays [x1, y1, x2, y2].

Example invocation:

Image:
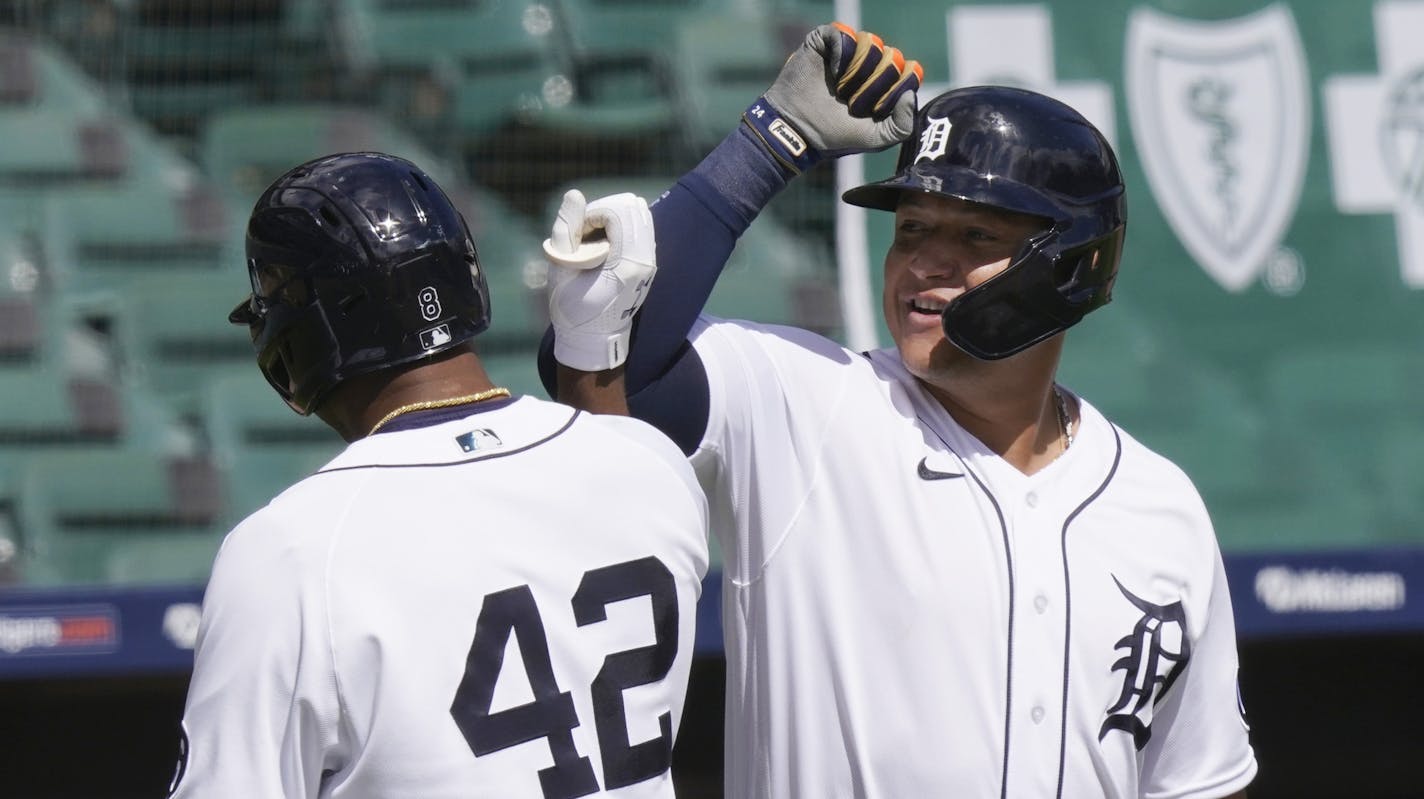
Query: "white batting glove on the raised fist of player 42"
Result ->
[[544, 189, 658, 372]]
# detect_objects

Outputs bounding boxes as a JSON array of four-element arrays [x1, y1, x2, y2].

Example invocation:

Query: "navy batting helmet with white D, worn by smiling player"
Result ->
[[844, 85, 1128, 360]]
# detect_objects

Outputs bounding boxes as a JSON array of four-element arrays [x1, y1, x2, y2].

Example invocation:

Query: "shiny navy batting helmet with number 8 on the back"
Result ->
[[228, 152, 490, 416]]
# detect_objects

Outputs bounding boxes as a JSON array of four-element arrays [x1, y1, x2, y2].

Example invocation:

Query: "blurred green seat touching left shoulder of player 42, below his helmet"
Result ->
[[201, 365, 346, 526]]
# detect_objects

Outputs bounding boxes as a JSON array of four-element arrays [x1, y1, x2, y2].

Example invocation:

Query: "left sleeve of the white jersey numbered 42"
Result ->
[[174, 514, 343, 799]]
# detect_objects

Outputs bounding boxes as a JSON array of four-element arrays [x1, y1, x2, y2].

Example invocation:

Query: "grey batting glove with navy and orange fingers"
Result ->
[[742, 23, 924, 174]]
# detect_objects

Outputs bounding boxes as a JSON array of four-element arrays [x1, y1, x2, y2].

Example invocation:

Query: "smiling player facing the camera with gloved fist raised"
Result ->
[[541, 26, 1256, 799]]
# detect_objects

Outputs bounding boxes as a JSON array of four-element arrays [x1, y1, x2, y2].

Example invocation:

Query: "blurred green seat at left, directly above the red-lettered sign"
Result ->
[[17, 450, 226, 585]]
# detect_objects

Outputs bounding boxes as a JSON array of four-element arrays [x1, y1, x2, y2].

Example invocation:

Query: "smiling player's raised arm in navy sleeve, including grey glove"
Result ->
[[540, 23, 923, 451]]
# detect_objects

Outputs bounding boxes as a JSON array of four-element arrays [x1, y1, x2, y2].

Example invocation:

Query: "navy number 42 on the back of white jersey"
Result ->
[[450, 557, 678, 799]]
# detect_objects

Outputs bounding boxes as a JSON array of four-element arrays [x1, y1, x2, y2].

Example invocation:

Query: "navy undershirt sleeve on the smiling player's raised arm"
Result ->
[[538, 125, 790, 453]]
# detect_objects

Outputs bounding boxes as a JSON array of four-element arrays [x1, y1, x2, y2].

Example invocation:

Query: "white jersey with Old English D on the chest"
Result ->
[[691, 318, 1256, 799]]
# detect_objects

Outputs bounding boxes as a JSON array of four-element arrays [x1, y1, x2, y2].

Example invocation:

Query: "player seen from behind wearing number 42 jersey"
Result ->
[[174, 152, 708, 799]]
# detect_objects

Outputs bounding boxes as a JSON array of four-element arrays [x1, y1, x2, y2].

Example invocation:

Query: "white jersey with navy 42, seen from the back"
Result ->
[[177, 397, 708, 799]]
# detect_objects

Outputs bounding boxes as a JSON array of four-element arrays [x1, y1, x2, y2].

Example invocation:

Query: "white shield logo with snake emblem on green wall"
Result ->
[[1125, 3, 1310, 292]]
